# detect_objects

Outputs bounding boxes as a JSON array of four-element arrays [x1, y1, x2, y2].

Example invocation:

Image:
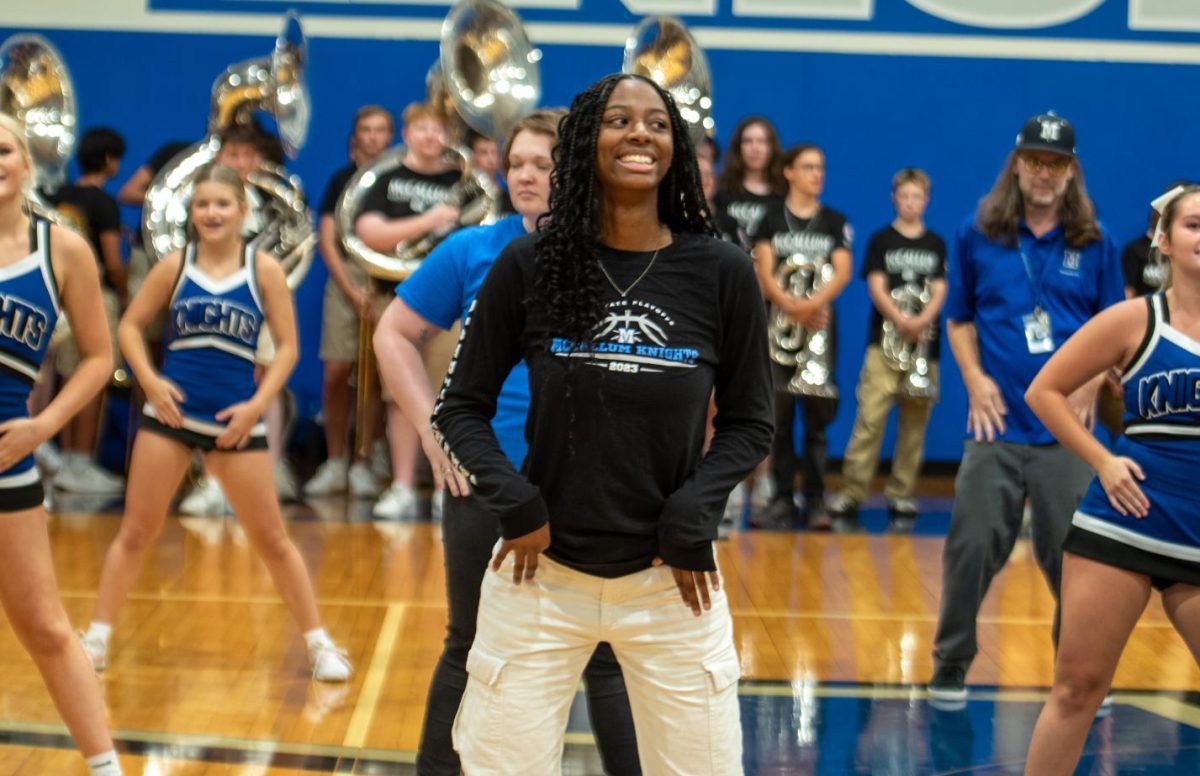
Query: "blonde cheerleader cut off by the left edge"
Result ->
[[0, 114, 121, 776]]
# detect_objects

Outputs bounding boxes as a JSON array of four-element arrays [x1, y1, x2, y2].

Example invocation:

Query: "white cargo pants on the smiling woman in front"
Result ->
[[454, 555, 742, 776]]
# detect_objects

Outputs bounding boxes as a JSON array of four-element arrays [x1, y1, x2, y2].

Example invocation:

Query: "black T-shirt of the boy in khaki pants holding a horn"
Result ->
[[863, 224, 946, 360]]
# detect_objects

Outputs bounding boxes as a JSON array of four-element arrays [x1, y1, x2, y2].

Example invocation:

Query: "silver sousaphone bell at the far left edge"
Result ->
[[0, 32, 78, 221]]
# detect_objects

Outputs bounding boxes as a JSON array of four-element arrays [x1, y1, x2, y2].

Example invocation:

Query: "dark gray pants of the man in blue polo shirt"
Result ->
[[934, 439, 1092, 669]]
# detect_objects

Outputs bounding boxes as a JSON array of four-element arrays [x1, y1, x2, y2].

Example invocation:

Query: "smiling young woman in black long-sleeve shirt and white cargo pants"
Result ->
[[433, 74, 770, 776]]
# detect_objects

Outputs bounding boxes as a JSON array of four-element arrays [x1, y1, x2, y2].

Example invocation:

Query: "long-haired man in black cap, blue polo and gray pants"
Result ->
[[929, 113, 1124, 703]]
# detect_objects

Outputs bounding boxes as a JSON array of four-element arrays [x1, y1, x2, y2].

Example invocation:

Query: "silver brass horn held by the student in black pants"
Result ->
[[767, 253, 838, 398]]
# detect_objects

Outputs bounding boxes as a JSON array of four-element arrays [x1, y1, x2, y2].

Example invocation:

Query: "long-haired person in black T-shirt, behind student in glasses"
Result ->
[[713, 116, 787, 251]]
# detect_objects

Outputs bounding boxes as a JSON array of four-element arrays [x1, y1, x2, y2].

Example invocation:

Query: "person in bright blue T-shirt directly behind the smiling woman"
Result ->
[[374, 110, 641, 776]]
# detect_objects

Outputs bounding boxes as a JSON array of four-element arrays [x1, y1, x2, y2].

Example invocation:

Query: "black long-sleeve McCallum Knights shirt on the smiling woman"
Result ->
[[433, 234, 772, 577]]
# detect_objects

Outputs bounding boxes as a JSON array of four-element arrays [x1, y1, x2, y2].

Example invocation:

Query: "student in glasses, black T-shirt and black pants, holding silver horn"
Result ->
[[754, 144, 852, 529]]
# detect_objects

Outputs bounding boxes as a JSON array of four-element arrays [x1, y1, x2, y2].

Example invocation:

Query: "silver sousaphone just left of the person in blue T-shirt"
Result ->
[[335, 0, 541, 281]]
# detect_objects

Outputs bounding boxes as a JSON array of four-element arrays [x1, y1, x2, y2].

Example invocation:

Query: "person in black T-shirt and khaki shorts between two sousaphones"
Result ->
[[304, 106, 396, 498]]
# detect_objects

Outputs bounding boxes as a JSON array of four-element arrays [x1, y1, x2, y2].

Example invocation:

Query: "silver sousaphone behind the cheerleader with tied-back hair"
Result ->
[[142, 12, 317, 288]]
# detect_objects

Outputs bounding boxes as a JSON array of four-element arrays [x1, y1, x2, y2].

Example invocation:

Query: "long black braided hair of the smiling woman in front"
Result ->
[[534, 73, 716, 344]]
